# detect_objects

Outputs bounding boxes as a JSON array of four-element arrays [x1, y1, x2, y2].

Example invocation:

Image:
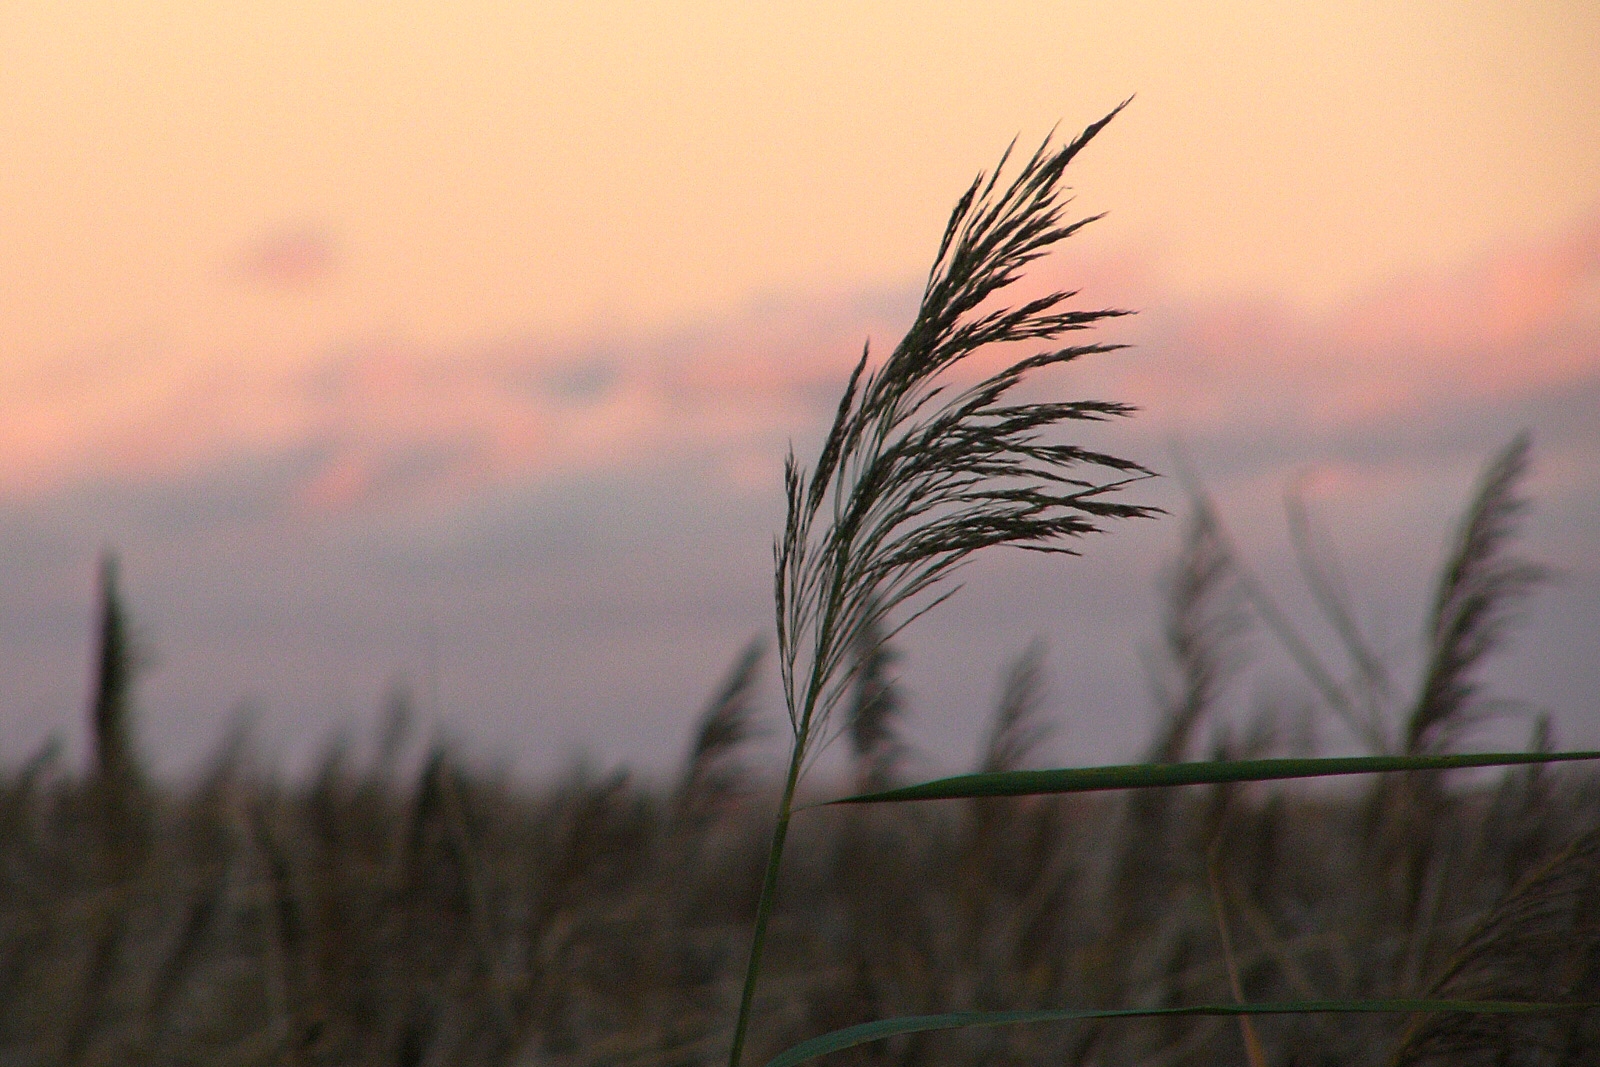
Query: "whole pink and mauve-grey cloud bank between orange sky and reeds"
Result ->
[[0, 216, 1600, 780]]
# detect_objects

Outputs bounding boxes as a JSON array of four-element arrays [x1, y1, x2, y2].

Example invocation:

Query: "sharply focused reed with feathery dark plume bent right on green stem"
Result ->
[[728, 101, 1158, 1067]]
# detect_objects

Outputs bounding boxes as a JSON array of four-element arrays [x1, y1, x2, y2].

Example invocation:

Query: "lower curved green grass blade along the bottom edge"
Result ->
[[765, 1000, 1600, 1067]]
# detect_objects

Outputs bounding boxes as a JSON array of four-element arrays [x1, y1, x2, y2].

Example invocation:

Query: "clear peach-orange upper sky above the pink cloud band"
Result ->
[[0, 0, 1600, 356]]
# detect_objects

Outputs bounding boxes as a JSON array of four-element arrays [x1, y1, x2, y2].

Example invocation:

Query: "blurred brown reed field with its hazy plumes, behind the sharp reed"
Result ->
[[9, 442, 1600, 1065]]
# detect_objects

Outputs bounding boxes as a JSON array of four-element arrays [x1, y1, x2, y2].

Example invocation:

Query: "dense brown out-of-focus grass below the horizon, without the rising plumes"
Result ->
[[0, 703, 1600, 1064]]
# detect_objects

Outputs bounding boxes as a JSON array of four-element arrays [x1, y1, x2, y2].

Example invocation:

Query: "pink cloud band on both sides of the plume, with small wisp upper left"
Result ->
[[12, 218, 1600, 510]]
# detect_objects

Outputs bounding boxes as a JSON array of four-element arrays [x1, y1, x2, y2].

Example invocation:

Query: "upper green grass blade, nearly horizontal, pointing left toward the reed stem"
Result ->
[[813, 752, 1600, 806]]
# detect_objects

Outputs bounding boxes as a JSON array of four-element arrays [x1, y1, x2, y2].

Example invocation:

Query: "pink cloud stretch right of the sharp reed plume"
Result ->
[[1112, 216, 1600, 432]]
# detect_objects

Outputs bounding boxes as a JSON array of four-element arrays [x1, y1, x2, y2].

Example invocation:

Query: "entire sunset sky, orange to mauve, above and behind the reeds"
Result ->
[[0, 0, 1600, 783]]
